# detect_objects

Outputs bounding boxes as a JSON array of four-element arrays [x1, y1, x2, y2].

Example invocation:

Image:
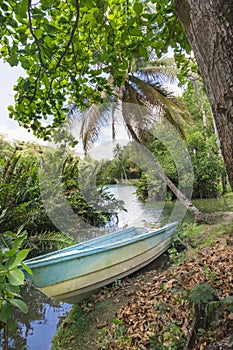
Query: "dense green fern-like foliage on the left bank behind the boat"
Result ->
[[0, 133, 124, 249]]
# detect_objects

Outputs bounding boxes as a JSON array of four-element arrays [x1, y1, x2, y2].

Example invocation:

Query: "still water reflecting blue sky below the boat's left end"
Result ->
[[0, 285, 72, 350]]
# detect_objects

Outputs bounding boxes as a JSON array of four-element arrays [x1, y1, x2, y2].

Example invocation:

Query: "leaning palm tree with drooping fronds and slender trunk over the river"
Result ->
[[69, 59, 206, 220]]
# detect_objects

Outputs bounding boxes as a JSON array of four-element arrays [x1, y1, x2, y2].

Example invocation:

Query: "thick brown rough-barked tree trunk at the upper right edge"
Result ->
[[174, 0, 233, 190]]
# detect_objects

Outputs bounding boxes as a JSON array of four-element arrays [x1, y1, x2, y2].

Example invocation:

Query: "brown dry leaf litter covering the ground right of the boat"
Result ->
[[83, 235, 233, 350]]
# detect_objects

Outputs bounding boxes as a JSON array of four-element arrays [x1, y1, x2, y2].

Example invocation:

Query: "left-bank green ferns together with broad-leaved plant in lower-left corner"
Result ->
[[0, 136, 122, 339]]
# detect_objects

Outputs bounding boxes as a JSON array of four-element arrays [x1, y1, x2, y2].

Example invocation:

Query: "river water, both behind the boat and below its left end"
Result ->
[[0, 185, 233, 350]]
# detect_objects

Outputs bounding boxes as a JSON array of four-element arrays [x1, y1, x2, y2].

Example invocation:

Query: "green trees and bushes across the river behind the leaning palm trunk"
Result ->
[[95, 83, 226, 200]]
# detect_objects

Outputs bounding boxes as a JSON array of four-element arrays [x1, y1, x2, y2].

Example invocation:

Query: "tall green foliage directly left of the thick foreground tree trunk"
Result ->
[[183, 86, 226, 198]]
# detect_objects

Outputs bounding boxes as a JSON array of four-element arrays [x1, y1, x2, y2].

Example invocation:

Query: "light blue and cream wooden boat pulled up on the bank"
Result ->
[[24, 222, 178, 303]]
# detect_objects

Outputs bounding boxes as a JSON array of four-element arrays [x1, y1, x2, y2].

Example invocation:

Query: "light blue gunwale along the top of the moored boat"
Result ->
[[24, 222, 178, 268]]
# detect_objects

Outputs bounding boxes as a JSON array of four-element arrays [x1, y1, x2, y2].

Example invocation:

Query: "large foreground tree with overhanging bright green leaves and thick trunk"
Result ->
[[1, 0, 233, 191]]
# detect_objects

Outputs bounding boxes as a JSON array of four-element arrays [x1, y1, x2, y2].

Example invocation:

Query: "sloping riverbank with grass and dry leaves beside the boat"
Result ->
[[52, 213, 233, 350]]
